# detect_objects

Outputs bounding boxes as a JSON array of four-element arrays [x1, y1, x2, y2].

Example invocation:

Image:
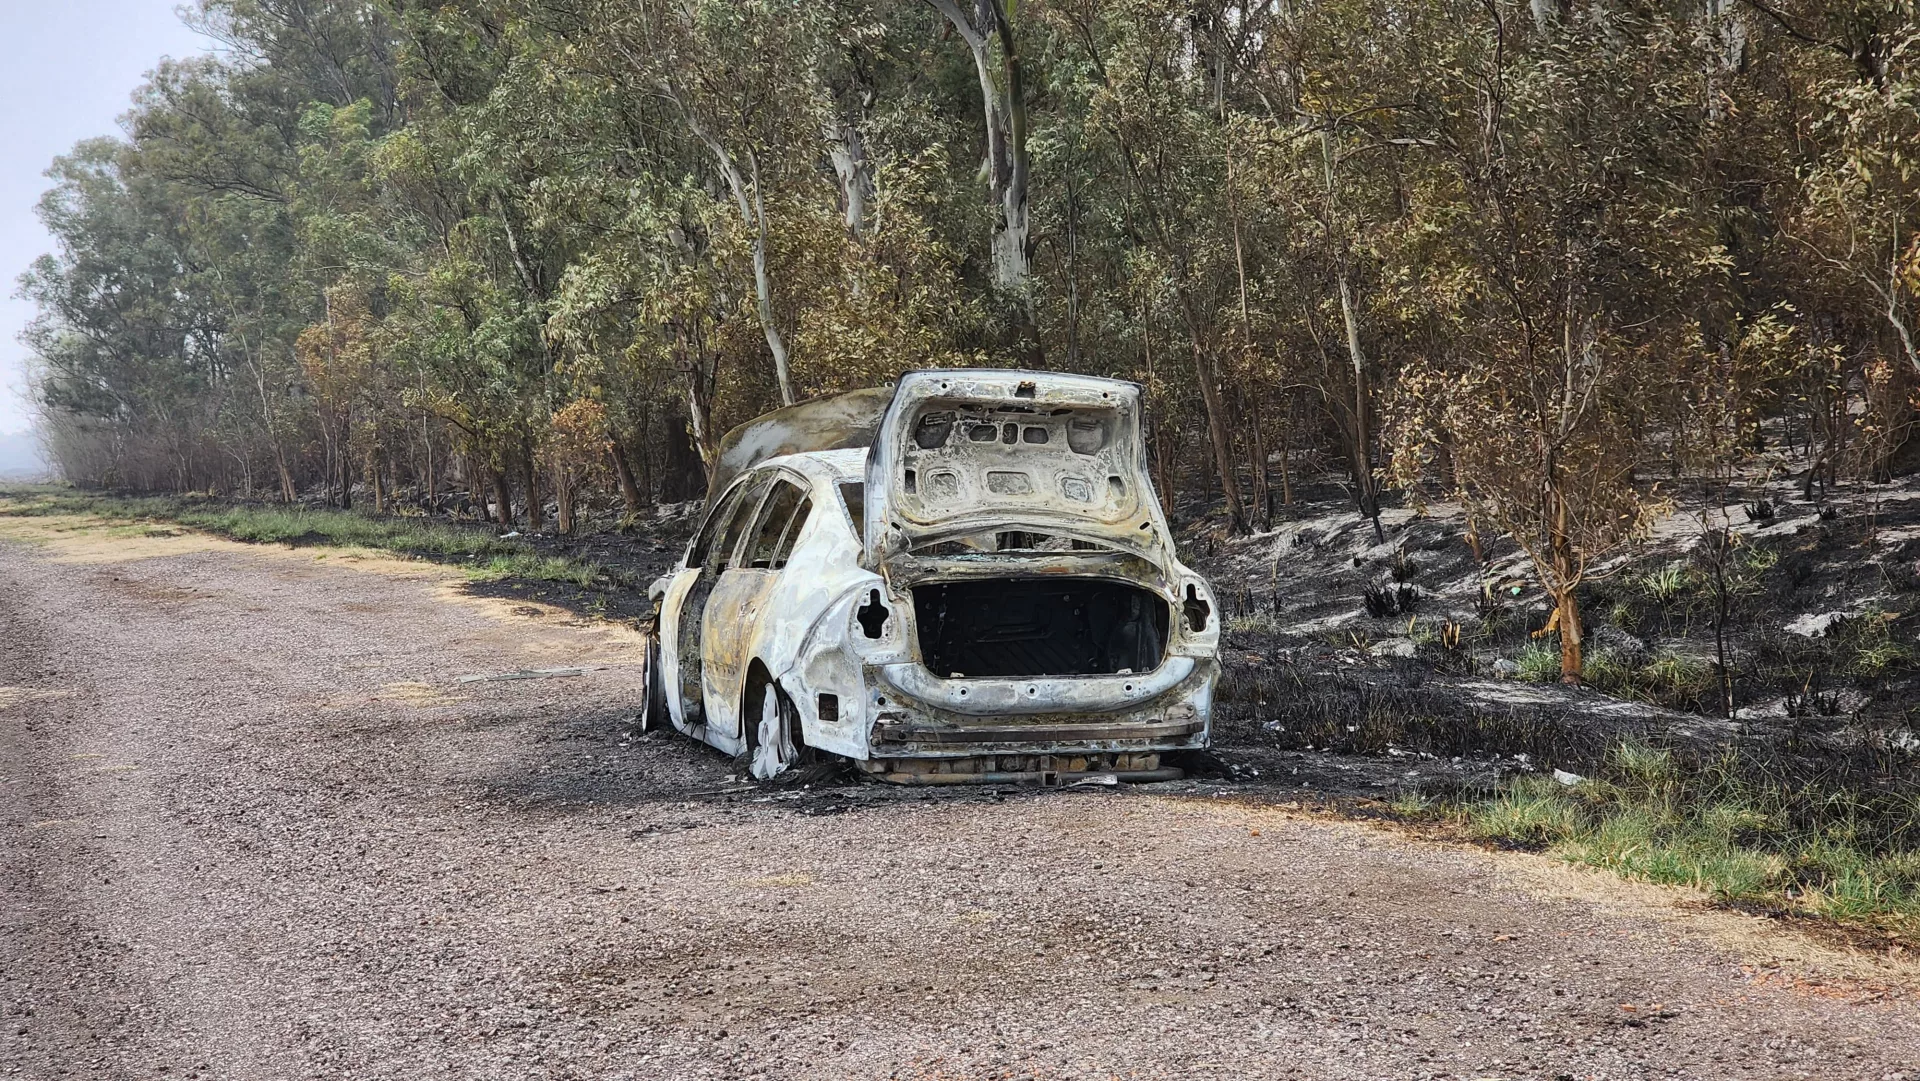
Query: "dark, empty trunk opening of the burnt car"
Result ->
[[914, 578, 1169, 678]]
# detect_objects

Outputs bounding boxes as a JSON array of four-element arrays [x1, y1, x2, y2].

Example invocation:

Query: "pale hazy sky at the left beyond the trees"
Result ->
[[0, 0, 209, 436]]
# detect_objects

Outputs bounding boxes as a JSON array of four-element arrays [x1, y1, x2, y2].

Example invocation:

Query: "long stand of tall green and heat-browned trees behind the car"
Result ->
[[21, 0, 1920, 672]]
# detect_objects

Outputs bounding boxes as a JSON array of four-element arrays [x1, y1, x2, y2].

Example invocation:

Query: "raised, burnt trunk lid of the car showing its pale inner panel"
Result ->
[[866, 369, 1171, 568]]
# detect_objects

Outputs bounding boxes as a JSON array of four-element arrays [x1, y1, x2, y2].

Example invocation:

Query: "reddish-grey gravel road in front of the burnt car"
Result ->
[[0, 520, 1920, 1081]]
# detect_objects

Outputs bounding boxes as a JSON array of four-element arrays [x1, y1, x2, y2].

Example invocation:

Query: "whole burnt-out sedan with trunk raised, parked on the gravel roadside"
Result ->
[[643, 371, 1219, 783]]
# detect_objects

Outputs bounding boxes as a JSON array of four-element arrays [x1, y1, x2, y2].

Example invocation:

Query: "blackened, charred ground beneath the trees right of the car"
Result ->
[[1181, 474, 1920, 818]]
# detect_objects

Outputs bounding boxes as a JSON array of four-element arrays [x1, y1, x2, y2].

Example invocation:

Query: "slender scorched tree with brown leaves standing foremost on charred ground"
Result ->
[[1398, 2, 1728, 682]]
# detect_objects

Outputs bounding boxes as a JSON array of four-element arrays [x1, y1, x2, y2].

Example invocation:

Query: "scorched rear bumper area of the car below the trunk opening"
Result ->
[[868, 659, 1219, 764]]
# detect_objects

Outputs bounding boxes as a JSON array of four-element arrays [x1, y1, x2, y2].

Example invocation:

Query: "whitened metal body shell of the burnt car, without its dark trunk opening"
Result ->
[[653, 371, 1219, 780]]
